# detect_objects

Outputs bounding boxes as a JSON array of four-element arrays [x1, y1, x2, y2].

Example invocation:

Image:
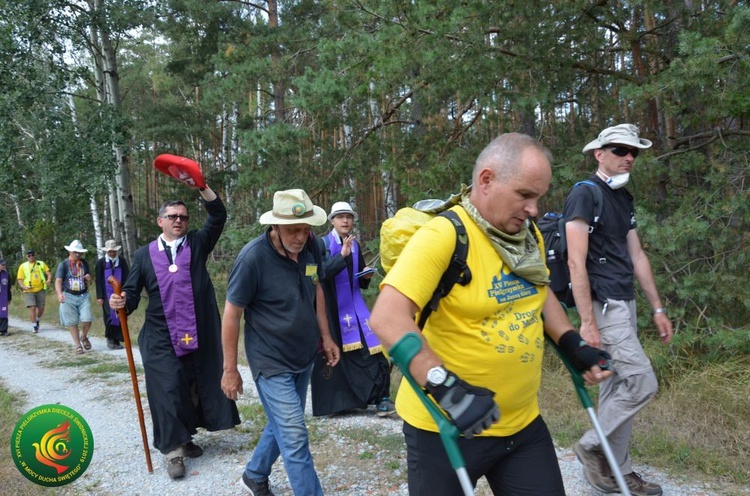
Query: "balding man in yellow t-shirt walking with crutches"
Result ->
[[370, 133, 611, 496]]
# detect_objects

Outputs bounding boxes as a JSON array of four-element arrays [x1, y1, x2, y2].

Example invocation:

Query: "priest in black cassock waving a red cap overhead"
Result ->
[[110, 183, 240, 479]]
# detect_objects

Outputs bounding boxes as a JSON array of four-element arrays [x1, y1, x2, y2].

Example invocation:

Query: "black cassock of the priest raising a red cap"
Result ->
[[123, 198, 240, 453]]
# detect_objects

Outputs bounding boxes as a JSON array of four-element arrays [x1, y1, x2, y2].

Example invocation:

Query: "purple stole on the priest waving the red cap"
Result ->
[[148, 238, 198, 357]]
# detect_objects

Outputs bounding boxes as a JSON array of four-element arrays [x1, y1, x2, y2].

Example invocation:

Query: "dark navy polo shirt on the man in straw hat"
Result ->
[[227, 231, 320, 379]]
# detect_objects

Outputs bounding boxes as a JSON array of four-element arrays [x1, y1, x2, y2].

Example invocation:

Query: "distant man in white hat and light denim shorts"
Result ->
[[55, 239, 93, 355]]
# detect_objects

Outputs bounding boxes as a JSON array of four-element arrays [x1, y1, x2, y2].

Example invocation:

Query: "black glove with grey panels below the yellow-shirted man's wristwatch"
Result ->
[[427, 371, 500, 439]]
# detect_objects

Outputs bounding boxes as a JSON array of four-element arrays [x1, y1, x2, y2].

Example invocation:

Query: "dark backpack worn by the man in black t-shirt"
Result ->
[[537, 179, 604, 308]]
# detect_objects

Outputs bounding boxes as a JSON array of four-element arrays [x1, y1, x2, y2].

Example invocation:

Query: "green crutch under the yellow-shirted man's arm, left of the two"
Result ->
[[389, 332, 474, 496]]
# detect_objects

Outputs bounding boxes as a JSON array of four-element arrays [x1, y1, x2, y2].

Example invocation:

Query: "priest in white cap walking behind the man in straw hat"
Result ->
[[310, 201, 396, 417]]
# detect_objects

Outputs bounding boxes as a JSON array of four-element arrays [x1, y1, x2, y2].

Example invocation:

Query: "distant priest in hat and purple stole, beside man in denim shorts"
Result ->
[[94, 239, 130, 350]]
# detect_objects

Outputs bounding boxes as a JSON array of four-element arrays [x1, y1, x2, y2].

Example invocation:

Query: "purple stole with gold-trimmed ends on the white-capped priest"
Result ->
[[327, 231, 383, 355]]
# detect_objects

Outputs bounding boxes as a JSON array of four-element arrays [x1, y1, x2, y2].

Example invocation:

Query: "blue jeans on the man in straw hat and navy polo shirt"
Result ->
[[245, 364, 323, 496]]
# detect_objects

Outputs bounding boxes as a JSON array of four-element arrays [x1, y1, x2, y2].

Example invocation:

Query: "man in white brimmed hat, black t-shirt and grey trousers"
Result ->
[[564, 124, 672, 495]]
